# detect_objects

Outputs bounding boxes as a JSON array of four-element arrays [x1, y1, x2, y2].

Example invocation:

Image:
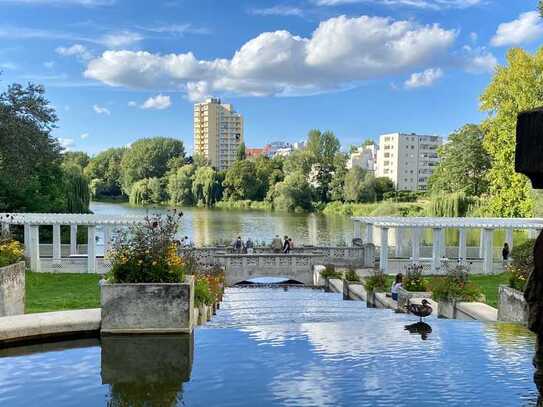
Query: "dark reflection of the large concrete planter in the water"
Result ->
[[101, 335, 194, 407]]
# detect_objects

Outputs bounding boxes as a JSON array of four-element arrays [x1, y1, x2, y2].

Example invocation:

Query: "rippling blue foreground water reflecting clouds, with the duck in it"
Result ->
[[0, 288, 536, 407]]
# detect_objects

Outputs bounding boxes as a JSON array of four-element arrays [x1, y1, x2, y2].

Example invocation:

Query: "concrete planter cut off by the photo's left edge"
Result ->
[[0, 261, 25, 317]]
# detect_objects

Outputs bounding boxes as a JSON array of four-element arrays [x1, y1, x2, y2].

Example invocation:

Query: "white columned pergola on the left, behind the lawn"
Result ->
[[0, 213, 144, 273]]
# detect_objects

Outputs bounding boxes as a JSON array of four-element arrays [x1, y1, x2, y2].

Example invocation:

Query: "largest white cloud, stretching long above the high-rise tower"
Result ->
[[84, 16, 457, 100]]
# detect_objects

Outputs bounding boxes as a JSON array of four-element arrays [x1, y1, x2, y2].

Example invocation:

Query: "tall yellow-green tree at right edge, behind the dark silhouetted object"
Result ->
[[481, 48, 543, 217]]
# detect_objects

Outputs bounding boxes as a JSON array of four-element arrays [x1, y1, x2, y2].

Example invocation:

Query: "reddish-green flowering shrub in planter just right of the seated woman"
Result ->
[[430, 264, 481, 301]]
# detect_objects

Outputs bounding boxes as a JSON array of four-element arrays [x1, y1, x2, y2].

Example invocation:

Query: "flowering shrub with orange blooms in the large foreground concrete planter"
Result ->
[[107, 211, 185, 283]]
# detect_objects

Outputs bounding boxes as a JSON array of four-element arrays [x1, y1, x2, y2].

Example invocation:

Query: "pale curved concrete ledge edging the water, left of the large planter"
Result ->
[[0, 308, 101, 346]]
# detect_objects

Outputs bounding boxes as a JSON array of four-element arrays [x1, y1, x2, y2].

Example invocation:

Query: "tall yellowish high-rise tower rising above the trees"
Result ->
[[194, 98, 243, 171]]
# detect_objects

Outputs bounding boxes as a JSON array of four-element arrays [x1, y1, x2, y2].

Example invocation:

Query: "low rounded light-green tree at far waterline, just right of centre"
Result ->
[[273, 172, 313, 212]]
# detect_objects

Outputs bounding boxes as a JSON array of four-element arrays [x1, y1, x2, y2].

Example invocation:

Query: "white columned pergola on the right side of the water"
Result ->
[[352, 216, 543, 274]]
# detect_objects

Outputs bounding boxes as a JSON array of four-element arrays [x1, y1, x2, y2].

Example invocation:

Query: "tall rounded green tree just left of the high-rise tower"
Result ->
[[121, 137, 185, 192]]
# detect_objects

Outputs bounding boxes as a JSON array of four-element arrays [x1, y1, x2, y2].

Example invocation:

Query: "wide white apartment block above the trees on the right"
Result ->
[[375, 133, 443, 191]]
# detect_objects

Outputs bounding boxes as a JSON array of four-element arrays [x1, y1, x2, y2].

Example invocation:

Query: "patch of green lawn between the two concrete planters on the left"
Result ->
[[26, 272, 102, 314]]
